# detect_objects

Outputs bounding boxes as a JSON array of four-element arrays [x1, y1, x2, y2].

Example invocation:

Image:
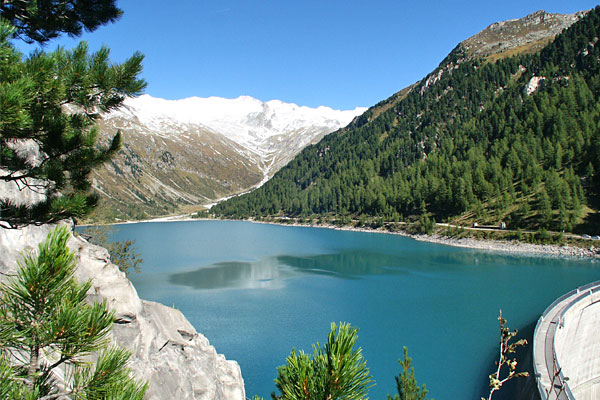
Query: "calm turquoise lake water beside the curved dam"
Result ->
[[96, 221, 600, 400]]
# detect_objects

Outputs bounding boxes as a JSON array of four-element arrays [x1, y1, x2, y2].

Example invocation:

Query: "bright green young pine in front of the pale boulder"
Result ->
[[0, 227, 146, 400]]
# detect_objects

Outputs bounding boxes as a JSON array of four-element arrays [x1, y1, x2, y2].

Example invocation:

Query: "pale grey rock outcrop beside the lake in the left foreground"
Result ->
[[0, 225, 245, 400]]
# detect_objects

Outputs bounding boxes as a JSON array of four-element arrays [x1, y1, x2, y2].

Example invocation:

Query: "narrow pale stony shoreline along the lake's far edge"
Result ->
[[84, 214, 600, 260]]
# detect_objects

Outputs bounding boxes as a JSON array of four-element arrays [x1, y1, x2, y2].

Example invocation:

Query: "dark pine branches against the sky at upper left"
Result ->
[[0, 0, 146, 228]]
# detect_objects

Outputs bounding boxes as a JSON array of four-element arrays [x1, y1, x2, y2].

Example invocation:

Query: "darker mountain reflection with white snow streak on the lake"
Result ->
[[169, 244, 588, 290]]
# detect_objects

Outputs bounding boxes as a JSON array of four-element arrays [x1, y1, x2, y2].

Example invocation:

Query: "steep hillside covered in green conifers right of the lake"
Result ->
[[213, 7, 600, 231]]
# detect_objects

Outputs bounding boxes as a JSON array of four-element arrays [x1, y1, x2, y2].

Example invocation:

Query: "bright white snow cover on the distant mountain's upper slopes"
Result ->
[[105, 95, 366, 158]]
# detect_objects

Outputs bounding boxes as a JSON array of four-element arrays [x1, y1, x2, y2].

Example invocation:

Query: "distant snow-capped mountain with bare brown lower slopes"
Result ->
[[89, 95, 365, 223]]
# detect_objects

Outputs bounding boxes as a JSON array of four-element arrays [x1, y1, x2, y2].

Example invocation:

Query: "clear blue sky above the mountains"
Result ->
[[16, 0, 597, 109]]
